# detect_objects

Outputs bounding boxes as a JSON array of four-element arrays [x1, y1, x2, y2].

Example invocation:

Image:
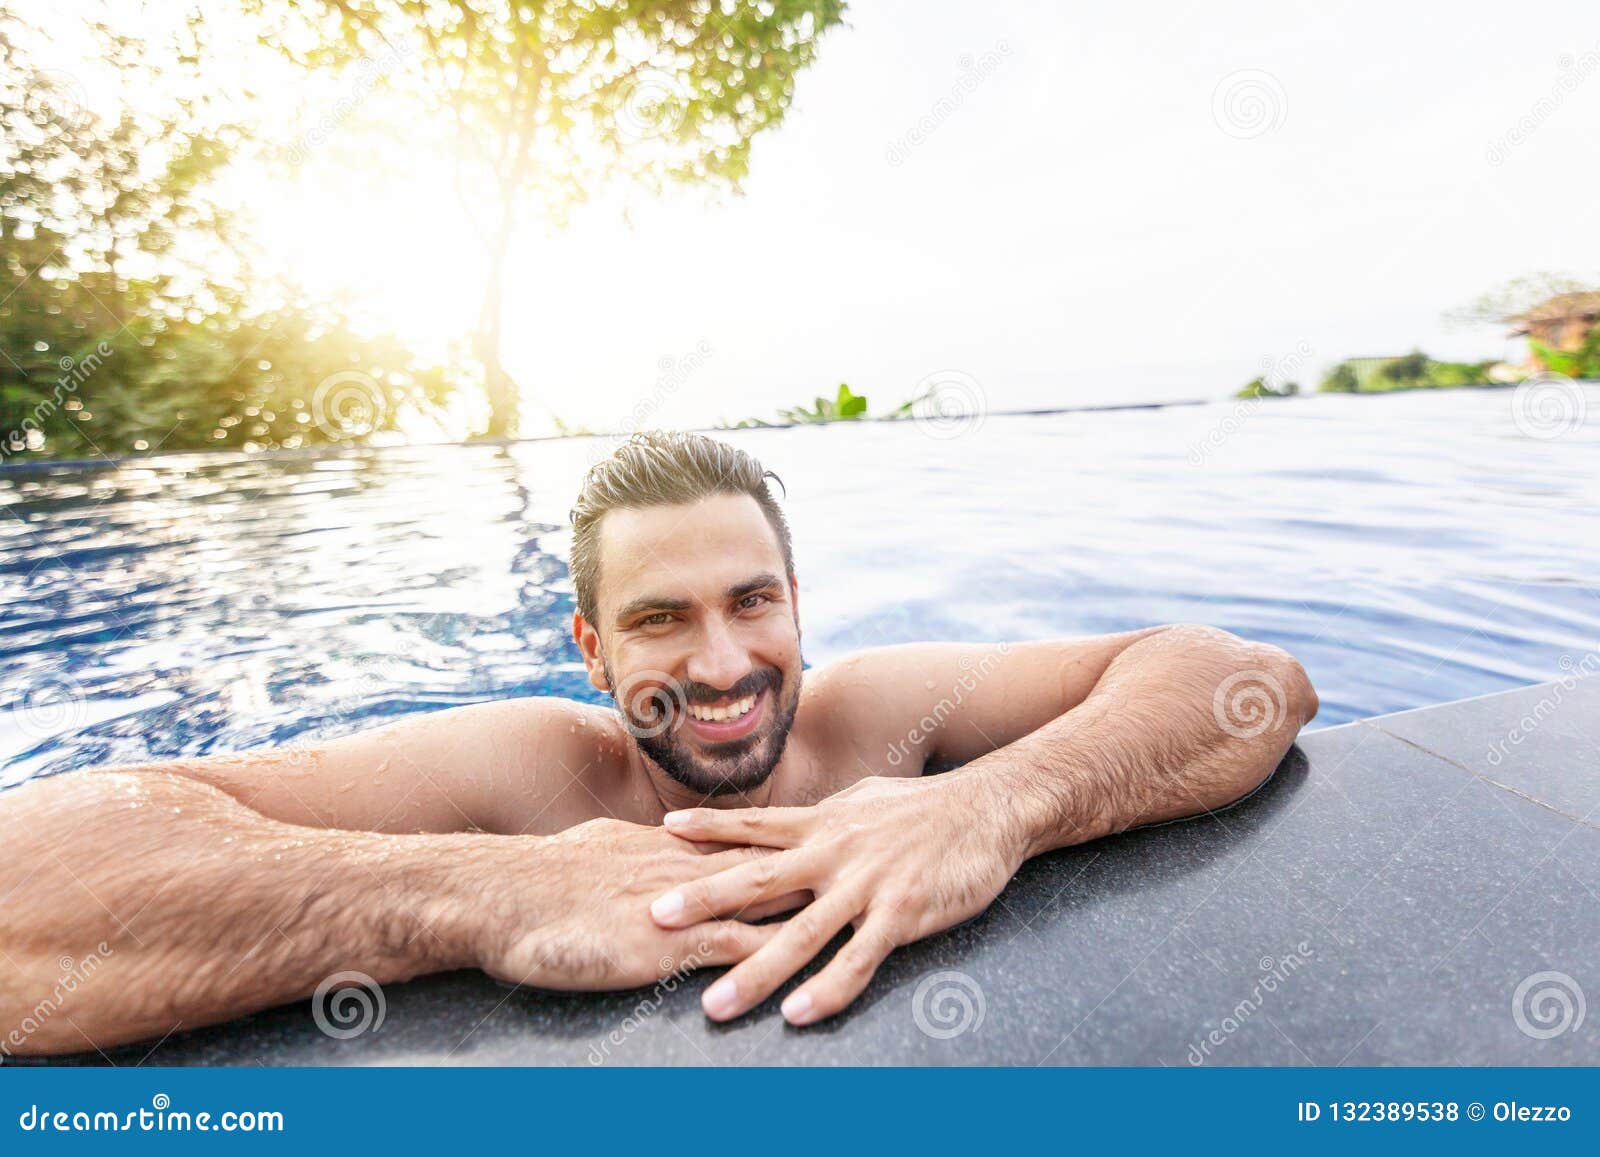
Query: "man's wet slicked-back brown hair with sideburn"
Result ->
[[570, 430, 795, 623]]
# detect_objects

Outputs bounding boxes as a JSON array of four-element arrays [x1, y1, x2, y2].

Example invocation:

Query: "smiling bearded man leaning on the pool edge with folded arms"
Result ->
[[0, 434, 1317, 1053]]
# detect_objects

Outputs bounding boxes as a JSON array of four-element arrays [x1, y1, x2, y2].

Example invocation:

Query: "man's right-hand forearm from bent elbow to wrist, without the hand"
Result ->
[[952, 627, 1317, 858]]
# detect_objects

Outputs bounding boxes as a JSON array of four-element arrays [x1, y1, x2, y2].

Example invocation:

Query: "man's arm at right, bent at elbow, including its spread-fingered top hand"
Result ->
[[651, 627, 1317, 1024]]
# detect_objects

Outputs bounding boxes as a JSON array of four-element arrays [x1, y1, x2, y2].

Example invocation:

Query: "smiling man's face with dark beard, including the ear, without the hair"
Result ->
[[574, 494, 802, 795]]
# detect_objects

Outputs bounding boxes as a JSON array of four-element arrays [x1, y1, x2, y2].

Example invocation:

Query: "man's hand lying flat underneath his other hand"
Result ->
[[467, 819, 779, 989]]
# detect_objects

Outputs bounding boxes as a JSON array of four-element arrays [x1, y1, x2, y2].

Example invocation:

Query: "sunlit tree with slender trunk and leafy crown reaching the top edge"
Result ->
[[250, 0, 845, 435]]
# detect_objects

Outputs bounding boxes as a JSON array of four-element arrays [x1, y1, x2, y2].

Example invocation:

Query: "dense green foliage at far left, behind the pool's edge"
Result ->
[[0, 13, 461, 456]]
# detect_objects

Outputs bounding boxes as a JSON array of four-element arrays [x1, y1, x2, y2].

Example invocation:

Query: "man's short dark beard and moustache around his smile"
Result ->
[[606, 667, 800, 797]]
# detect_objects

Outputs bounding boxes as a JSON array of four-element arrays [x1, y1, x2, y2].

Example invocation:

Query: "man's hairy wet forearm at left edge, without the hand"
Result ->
[[0, 771, 483, 1055]]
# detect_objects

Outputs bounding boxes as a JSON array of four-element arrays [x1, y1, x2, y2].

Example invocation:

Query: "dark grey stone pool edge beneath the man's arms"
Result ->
[[28, 672, 1600, 1066]]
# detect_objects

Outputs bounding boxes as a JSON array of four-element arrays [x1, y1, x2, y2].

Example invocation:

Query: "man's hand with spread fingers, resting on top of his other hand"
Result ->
[[650, 775, 1024, 1024]]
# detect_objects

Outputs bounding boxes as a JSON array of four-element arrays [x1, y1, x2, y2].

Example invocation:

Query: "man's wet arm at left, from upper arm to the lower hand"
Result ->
[[0, 697, 773, 1055]]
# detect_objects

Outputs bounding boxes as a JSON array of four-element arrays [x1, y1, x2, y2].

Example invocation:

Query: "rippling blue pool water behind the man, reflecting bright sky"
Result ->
[[0, 386, 1600, 784]]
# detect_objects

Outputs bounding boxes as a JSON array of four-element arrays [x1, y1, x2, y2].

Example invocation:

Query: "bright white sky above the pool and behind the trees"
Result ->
[[28, 0, 1600, 429]]
